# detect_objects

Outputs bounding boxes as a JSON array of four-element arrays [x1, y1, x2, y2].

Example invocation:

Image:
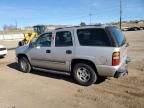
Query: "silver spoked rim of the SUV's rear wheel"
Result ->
[[77, 67, 90, 82]]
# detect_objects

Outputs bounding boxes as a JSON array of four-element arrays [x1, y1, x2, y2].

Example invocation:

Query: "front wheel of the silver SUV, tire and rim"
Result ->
[[18, 57, 32, 73]]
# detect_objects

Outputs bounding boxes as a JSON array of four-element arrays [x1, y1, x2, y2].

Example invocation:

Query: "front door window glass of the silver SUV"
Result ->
[[36, 33, 52, 47]]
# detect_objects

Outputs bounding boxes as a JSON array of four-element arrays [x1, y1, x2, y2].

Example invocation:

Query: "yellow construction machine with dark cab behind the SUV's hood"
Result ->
[[18, 25, 46, 46]]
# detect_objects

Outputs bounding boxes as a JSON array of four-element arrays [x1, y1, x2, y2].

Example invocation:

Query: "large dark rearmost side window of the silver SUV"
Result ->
[[77, 28, 111, 46]]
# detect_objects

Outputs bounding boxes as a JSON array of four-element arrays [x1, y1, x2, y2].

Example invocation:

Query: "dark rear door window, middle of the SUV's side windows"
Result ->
[[55, 31, 72, 47]]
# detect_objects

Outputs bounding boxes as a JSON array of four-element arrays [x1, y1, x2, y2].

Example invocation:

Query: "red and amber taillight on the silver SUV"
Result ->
[[112, 52, 120, 66]]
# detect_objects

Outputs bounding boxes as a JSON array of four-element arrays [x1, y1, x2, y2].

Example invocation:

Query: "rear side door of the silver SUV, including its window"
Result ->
[[51, 30, 74, 71]]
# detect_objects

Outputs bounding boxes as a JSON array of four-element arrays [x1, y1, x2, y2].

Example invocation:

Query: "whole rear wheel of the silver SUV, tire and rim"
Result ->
[[73, 63, 97, 86]]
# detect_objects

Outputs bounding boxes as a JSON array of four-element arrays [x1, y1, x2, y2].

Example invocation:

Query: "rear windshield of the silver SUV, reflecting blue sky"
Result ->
[[108, 27, 126, 46]]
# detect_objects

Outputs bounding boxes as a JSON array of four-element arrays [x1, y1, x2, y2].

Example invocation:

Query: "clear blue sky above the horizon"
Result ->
[[0, 0, 144, 29]]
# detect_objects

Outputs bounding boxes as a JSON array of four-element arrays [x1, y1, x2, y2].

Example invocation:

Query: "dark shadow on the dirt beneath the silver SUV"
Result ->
[[7, 63, 106, 84]]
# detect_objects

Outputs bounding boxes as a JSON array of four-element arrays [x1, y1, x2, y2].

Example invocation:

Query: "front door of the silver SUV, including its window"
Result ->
[[28, 33, 52, 68]]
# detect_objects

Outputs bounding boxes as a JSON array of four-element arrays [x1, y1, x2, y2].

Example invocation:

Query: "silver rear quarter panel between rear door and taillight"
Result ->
[[75, 46, 115, 65]]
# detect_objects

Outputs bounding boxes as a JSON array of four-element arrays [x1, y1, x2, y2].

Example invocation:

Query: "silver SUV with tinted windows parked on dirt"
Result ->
[[16, 25, 128, 86]]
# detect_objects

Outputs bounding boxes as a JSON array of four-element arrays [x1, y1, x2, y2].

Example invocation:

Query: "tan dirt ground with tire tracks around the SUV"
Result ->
[[0, 31, 144, 108]]
